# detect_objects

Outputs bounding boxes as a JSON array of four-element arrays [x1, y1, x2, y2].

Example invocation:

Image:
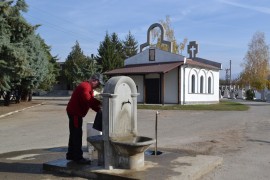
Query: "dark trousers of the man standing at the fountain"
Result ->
[[66, 114, 83, 160]]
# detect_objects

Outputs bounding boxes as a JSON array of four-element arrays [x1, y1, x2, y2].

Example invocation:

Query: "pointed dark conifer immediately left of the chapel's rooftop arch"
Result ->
[[123, 31, 138, 59]]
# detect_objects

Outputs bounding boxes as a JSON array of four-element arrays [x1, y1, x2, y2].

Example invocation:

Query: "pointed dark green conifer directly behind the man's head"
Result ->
[[64, 41, 97, 87]]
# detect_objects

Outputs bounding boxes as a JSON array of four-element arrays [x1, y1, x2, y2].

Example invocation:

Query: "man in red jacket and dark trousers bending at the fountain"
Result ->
[[66, 74, 104, 164]]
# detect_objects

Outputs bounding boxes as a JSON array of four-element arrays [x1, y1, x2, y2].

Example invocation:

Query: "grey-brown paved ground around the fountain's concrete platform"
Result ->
[[0, 99, 270, 180]]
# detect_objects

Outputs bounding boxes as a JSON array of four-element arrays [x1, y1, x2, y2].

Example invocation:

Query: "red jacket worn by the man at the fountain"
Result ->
[[66, 81, 101, 117]]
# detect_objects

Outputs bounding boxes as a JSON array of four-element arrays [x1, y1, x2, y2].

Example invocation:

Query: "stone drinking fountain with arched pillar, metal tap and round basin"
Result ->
[[98, 76, 155, 170]]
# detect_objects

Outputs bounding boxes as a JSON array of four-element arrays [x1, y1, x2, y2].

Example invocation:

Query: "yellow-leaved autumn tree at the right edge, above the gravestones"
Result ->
[[240, 32, 270, 90]]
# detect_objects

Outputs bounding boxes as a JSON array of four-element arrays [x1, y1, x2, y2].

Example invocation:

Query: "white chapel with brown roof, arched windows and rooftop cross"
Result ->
[[105, 23, 222, 105]]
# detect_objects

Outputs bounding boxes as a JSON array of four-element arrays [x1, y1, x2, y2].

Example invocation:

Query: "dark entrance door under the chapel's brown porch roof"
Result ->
[[145, 78, 160, 104]]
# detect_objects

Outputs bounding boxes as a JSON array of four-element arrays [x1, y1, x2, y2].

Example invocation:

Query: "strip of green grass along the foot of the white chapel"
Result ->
[[138, 101, 249, 111]]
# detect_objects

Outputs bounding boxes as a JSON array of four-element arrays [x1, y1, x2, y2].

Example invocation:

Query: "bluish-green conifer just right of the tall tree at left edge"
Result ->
[[21, 34, 60, 100]]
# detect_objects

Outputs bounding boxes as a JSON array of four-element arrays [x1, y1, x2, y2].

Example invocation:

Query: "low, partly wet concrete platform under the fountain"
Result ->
[[43, 149, 223, 180]]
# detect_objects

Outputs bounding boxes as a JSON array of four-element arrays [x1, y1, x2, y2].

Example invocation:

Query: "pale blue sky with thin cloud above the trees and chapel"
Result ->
[[24, 0, 270, 78]]
